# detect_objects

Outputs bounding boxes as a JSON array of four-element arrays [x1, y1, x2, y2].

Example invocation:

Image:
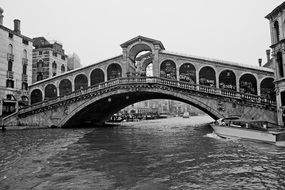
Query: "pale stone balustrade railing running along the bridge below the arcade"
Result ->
[[14, 77, 276, 113]]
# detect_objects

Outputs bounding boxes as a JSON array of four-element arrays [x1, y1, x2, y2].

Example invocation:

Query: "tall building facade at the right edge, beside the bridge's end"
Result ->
[[265, 2, 285, 125]]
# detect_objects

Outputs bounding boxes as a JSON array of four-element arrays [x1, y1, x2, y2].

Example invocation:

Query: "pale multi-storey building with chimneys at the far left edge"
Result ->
[[0, 8, 33, 116]]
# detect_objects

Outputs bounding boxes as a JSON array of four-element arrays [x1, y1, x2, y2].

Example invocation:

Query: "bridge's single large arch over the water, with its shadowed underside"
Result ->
[[58, 88, 224, 127]]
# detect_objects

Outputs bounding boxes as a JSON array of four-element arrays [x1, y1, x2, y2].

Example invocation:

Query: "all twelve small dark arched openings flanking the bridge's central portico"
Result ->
[[31, 60, 275, 104]]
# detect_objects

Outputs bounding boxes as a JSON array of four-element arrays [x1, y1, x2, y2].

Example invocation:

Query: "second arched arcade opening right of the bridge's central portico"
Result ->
[[179, 63, 196, 84]]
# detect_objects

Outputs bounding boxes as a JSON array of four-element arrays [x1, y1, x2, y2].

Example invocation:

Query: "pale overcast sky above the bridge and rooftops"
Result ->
[[0, 0, 283, 66]]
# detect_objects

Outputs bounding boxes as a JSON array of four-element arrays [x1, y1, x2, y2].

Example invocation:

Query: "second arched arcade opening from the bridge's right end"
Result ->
[[239, 74, 257, 95]]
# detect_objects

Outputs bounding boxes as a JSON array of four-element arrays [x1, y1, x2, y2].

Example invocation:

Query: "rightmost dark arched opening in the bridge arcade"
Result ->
[[260, 78, 276, 100]]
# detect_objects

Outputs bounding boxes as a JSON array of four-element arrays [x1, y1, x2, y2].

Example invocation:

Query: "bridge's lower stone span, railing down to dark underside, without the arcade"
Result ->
[[4, 77, 276, 127]]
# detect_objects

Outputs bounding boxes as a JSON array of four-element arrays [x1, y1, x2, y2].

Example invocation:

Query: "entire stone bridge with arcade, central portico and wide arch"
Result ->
[[3, 36, 276, 127]]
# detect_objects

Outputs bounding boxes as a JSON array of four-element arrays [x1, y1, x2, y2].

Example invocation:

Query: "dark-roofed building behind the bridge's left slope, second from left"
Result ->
[[32, 37, 68, 83]]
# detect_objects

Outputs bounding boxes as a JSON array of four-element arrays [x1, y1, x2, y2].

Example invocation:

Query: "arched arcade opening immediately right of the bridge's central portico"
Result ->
[[160, 60, 177, 80]]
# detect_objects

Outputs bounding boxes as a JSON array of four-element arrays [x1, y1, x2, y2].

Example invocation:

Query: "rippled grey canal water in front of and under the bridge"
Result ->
[[0, 116, 285, 190]]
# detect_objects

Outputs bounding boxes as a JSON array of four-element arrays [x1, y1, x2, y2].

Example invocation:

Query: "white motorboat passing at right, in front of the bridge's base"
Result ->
[[211, 118, 285, 147]]
